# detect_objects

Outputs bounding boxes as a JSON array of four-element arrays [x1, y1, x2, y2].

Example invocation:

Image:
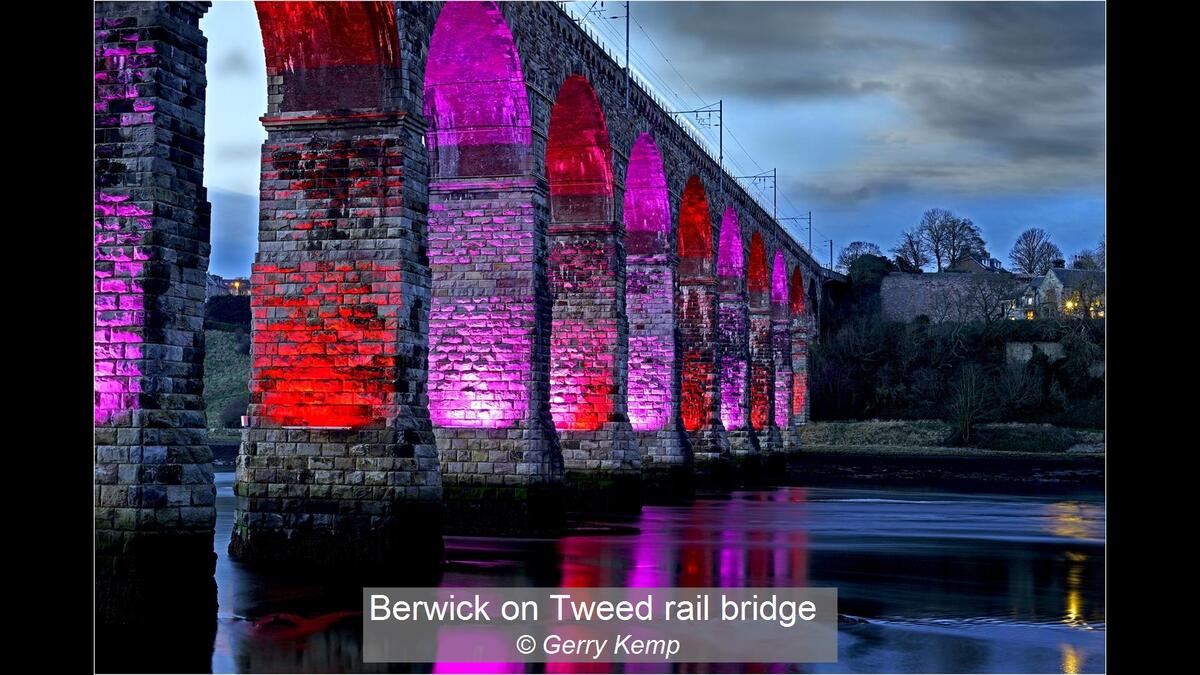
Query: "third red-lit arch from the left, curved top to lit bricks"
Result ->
[[678, 175, 716, 431]]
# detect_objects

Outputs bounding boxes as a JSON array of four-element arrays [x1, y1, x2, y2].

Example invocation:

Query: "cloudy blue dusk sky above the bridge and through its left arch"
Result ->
[[202, 1, 1105, 276]]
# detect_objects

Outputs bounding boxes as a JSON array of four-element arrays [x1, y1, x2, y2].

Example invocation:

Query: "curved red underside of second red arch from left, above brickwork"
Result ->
[[546, 74, 613, 223]]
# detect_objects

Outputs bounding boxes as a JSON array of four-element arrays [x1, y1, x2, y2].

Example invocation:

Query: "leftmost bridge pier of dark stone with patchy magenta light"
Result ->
[[94, 2, 216, 625]]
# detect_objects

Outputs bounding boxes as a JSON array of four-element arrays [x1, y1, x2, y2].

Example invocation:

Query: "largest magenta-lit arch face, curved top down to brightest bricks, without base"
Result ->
[[424, 2, 539, 427]]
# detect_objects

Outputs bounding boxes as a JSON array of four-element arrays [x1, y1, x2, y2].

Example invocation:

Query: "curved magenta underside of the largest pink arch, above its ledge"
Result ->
[[424, 2, 530, 177]]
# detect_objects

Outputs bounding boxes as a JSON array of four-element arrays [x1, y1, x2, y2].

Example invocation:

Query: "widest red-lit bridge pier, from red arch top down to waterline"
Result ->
[[229, 1, 442, 566]]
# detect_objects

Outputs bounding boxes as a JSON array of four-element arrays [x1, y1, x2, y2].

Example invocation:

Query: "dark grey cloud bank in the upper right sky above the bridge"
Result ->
[[634, 2, 1105, 196]]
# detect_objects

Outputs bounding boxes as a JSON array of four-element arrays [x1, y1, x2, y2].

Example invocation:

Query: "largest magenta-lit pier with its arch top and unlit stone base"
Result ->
[[422, 2, 562, 499]]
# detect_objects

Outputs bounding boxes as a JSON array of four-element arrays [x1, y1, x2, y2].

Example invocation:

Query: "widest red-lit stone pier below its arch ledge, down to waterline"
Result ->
[[230, 112, 442, 567]]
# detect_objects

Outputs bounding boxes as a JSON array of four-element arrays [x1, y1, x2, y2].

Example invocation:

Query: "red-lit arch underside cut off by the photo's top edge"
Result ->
[[254, 1, 401, 112]]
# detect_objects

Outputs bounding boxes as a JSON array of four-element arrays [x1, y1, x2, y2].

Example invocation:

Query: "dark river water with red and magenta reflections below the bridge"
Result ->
[[212, 473, 1105, 673]]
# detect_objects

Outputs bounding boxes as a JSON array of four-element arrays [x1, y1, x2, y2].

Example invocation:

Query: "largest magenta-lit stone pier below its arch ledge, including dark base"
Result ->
[[428, 179, 563, 523]]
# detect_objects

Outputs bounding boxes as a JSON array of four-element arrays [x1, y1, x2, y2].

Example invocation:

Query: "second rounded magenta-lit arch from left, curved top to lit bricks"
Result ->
[[624, 132, 676, 431]]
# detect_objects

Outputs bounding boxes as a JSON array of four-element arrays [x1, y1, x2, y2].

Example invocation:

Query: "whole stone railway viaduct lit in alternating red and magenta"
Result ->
[[95, 2, 838, 612]]
